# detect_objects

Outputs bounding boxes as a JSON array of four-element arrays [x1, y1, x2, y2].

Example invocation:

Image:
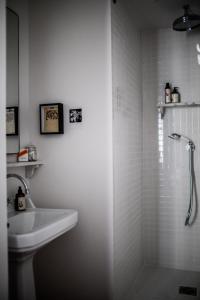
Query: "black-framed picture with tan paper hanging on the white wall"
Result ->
[[40, 103, 64, 134]]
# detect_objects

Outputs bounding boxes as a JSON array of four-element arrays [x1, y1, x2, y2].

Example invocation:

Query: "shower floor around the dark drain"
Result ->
[[126, 267, 200, 300]]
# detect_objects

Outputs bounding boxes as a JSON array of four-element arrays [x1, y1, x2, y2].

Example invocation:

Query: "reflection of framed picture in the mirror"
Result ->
[[6, 106, 19, 136]]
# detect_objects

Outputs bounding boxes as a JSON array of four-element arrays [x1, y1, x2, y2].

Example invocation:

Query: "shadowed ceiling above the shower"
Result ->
[[124, 0, 200, 29]]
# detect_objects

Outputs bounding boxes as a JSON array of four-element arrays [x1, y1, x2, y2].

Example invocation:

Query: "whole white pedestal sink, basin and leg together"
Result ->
[[8, 208, 78, 300]]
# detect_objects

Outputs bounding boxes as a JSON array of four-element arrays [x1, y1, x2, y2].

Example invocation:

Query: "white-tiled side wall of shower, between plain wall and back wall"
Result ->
[[112, 2, 142, 300]]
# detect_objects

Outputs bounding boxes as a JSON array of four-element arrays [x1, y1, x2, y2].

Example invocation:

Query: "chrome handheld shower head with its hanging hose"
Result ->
[[168, 133, 198, 226]]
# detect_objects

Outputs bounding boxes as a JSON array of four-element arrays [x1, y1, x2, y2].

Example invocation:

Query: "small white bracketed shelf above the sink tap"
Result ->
[[7, 161, 44, 178]]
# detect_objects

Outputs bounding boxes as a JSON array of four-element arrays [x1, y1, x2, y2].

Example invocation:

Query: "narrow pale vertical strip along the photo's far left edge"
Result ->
[[0, 0, 8, 300]]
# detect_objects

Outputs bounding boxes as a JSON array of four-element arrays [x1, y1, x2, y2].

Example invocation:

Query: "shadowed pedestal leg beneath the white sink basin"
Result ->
[[9, 253, 36, 300]]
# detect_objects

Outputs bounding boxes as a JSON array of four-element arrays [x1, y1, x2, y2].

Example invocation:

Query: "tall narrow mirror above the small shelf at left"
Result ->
[[6, 8, 19, 154]]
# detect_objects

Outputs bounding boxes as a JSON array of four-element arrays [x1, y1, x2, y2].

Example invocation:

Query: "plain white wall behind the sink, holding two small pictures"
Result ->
[[28, 0, 112, 300]]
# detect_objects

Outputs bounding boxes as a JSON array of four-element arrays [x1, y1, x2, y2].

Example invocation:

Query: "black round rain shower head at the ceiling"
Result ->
[[173, 5, 200, 31]]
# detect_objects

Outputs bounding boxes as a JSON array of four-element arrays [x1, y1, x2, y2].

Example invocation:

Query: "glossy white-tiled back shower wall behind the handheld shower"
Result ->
[[142, 29, 200, 271]]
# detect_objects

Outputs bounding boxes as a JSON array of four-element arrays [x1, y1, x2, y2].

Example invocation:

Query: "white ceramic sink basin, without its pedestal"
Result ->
[[8, 208, 78, 252]]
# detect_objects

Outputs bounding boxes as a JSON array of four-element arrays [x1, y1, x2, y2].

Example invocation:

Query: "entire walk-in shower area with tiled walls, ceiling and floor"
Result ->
[[112, 0, 200, 300]]
